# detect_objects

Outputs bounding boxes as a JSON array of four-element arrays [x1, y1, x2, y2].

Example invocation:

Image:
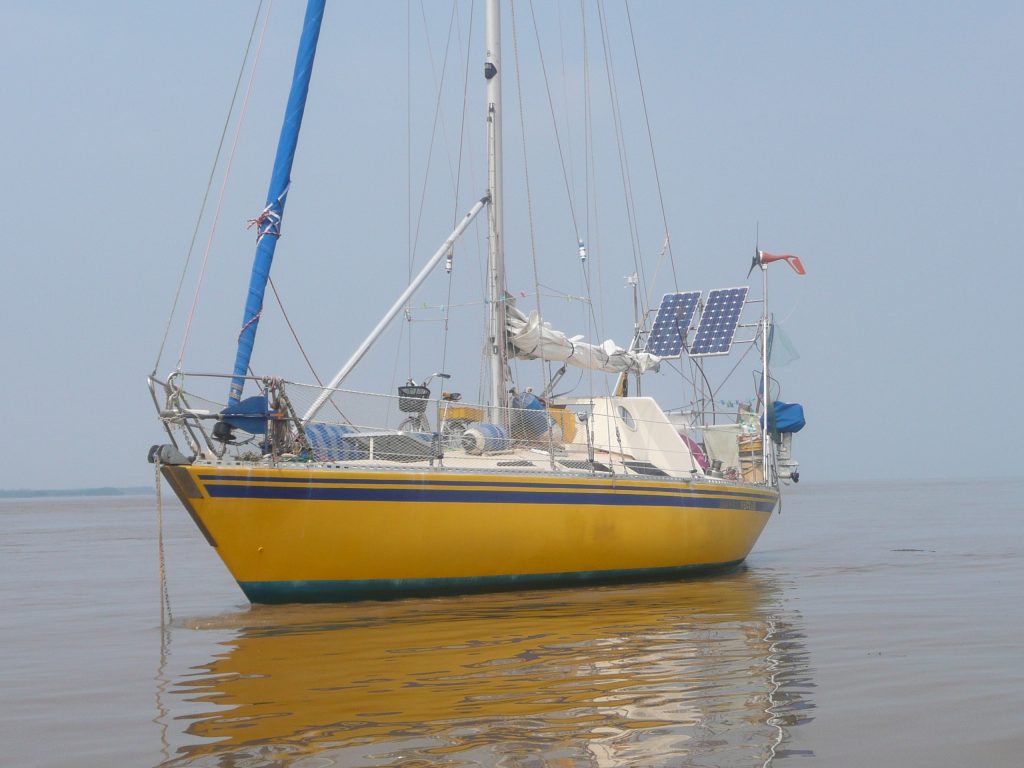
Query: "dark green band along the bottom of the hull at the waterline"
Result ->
[[239, 559, 742, 603]]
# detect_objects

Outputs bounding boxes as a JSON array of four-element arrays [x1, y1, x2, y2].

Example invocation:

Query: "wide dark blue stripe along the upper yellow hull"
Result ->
[[197, 482, 775, 512]]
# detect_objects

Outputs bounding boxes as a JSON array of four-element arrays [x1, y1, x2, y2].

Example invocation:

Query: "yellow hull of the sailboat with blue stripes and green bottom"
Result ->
[[164, 465, 778, 602]]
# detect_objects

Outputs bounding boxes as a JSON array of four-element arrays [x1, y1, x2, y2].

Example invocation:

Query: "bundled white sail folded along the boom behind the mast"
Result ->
[[505, 302, 662, 374]]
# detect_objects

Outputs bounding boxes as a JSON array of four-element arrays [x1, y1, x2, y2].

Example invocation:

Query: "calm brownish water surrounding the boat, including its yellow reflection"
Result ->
[[0, 480, 1024, 768]]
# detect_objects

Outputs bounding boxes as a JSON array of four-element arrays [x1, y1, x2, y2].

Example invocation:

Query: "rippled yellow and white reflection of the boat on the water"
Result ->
[[157, 571, 813, 767]]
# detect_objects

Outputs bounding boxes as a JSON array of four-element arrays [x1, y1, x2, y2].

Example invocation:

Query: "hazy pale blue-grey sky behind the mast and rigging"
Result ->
[[0, 0, 1024, 488]]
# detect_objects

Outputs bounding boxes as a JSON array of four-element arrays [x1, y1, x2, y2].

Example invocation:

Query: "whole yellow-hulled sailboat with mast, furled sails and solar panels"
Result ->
[[150, 0, 804, 603]]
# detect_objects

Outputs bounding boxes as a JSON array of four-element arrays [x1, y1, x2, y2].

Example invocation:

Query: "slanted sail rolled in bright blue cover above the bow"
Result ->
[[227, 0, 326, 406]]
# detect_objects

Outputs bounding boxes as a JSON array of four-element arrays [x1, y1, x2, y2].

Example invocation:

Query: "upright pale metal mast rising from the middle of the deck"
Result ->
[[483, 0, 508, 424]]
